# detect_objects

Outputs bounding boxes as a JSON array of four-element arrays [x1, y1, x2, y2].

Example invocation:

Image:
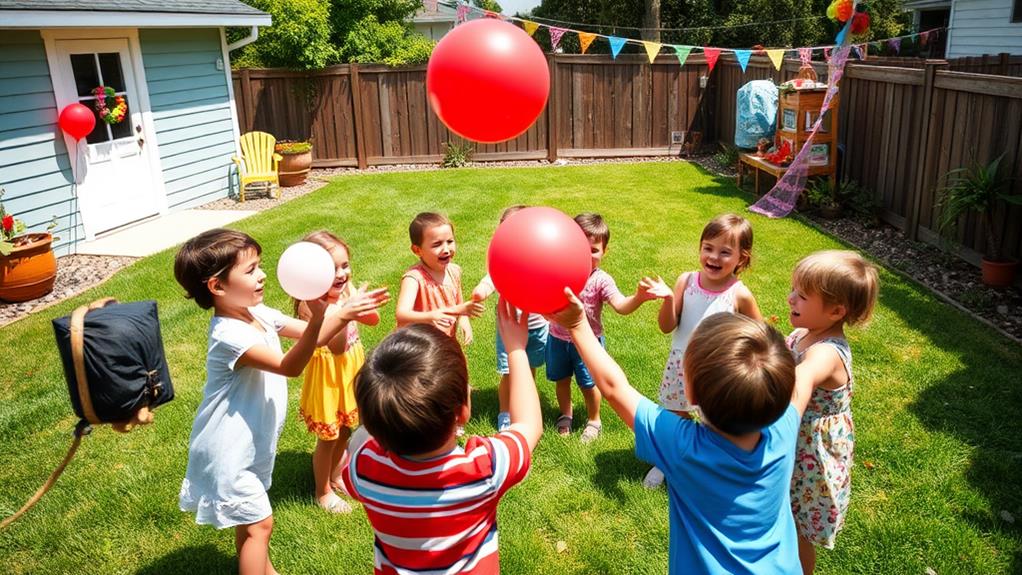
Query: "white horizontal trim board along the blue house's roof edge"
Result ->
[[0, 10, 273, 28]]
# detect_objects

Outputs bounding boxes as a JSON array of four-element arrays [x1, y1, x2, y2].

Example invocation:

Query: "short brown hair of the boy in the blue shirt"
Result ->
[[685, 312, 795, 435]]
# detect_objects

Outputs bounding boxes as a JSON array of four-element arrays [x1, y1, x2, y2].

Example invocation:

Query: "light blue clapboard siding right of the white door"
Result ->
[[139, 29, 236, 210]]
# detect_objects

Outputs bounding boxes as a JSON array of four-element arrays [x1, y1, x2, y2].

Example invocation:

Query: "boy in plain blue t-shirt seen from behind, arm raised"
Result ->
[[551, 290, 809, 574]]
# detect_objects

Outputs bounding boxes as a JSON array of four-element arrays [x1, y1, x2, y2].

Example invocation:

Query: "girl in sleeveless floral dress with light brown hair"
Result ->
[[788, 250, 879, 574]]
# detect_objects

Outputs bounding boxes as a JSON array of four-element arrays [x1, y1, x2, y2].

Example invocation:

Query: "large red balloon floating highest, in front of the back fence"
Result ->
[[426, 18, 550, 144]]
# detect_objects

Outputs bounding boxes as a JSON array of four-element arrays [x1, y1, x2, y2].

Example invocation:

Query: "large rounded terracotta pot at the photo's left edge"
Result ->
[[0, 233, 57, 302]]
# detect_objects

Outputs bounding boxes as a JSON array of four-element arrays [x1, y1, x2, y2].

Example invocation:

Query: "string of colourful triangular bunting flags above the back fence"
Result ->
[[435, 0, 948, 73]]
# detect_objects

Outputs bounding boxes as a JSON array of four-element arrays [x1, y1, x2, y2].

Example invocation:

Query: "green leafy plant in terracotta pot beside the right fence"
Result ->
[[939, 154, 1022, 287]]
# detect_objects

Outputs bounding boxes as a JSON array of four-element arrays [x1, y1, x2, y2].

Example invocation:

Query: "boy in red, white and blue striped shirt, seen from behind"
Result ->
[[341, 300, 543, 575]]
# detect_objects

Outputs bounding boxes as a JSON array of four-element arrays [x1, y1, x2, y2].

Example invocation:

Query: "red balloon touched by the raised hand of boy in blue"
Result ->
[[486, 207, 593, 314]]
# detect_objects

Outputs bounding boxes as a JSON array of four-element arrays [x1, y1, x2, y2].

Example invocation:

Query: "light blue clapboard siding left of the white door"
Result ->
[[0, 30, 85, 254]]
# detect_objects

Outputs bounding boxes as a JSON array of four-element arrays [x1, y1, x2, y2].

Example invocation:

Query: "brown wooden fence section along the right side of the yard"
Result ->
[[714, 58, 1022, 265]]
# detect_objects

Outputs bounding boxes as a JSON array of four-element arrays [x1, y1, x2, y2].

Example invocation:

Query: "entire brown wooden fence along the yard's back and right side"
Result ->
[[234, 55, 1022, 262]]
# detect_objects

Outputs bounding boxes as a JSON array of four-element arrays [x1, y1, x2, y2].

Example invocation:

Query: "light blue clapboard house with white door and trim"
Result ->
[[0, 0, 271, 253]]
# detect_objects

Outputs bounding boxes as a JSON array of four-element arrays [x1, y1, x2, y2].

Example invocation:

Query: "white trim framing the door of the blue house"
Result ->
[[39, 29, 168, 241]]
